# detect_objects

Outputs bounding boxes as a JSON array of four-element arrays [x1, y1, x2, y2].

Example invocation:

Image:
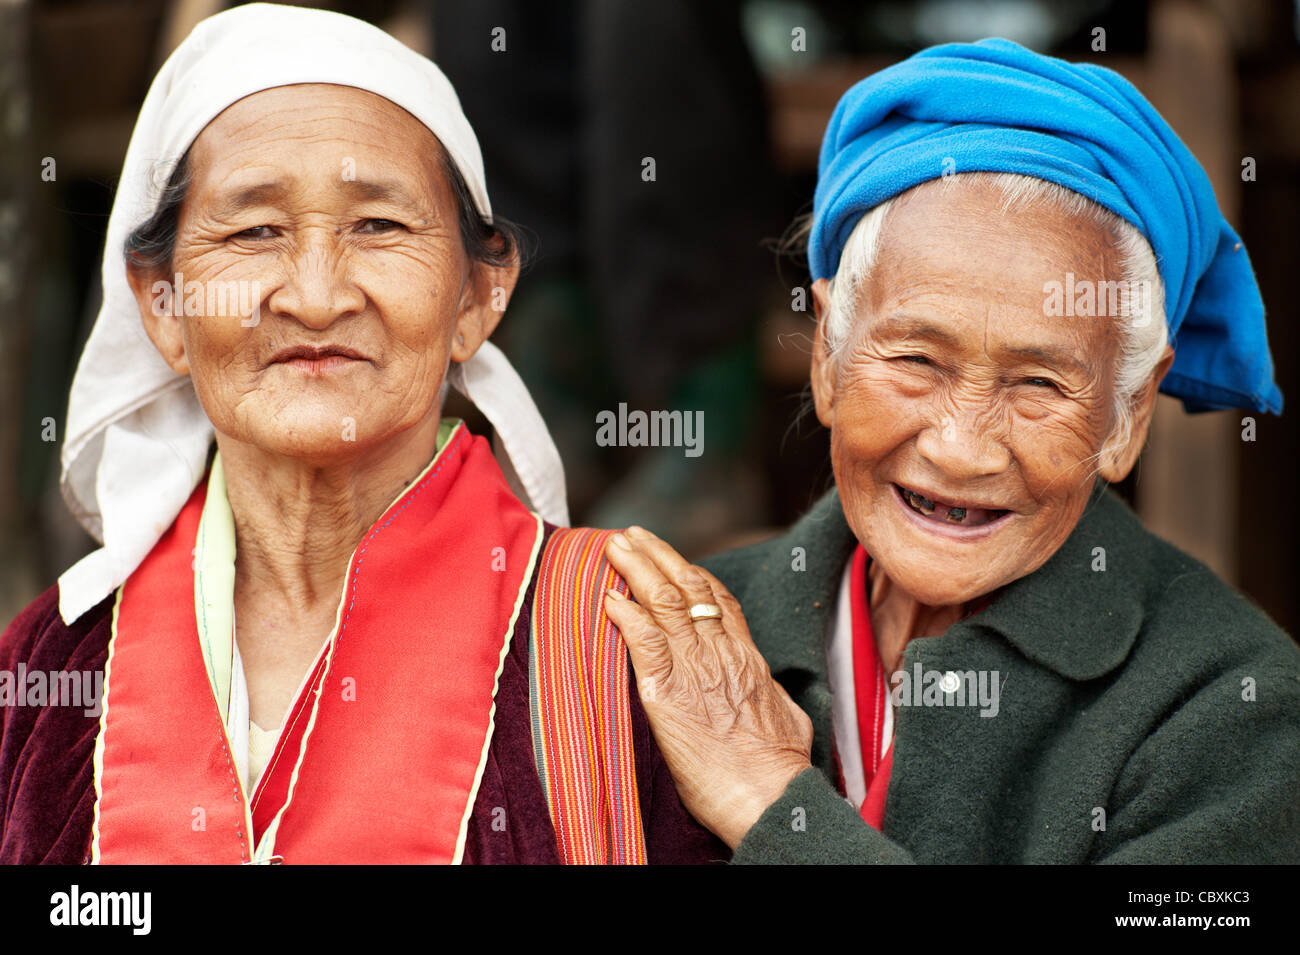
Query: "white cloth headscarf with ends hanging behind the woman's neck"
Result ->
[[59, 4, 568, 622]]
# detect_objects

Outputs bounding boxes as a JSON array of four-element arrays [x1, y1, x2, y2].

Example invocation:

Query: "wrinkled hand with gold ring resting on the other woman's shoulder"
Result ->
[[605, 528, 813, 848]]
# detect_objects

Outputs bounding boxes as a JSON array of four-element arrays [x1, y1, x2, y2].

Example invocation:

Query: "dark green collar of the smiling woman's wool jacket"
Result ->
[[737, 482, 1152, 682]]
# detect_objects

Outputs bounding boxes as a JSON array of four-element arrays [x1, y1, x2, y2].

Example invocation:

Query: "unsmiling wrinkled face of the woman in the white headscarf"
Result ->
[[127, 84, 517, 464]]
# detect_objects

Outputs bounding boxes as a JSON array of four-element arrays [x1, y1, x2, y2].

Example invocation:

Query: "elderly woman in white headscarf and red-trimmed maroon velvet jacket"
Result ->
[[0, 4, 719, 863]]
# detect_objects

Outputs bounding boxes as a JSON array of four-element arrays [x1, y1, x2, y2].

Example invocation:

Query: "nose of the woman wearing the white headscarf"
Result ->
[[267, 227, 365, 329]]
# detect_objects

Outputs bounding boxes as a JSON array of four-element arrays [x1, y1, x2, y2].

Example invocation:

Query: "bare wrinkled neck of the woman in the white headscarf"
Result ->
[[217, 408, 439, 612]]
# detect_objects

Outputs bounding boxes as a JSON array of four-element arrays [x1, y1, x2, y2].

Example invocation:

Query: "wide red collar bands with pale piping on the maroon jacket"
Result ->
[[95, 425, 542, 864]]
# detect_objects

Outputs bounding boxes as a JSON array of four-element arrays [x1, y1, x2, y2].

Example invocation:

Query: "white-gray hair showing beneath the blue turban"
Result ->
[[824, 173, 1169, 462]]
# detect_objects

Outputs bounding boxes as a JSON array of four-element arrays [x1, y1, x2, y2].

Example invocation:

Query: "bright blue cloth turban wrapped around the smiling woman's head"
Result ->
[[809, 39, 1282, 414]]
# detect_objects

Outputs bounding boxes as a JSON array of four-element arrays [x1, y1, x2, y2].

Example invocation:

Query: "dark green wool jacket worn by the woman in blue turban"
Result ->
[[703, 486, 1300, 863]]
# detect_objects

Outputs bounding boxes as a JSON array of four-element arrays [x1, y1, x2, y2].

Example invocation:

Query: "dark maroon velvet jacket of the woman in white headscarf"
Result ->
[[0, 537, 729, 864]]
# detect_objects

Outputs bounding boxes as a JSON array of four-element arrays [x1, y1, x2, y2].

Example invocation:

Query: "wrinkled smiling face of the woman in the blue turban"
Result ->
[[813, 181, 1145, 605]]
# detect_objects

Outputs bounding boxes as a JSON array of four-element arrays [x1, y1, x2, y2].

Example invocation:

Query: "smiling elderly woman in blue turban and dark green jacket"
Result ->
[[607, 40, 1300, 863]]
